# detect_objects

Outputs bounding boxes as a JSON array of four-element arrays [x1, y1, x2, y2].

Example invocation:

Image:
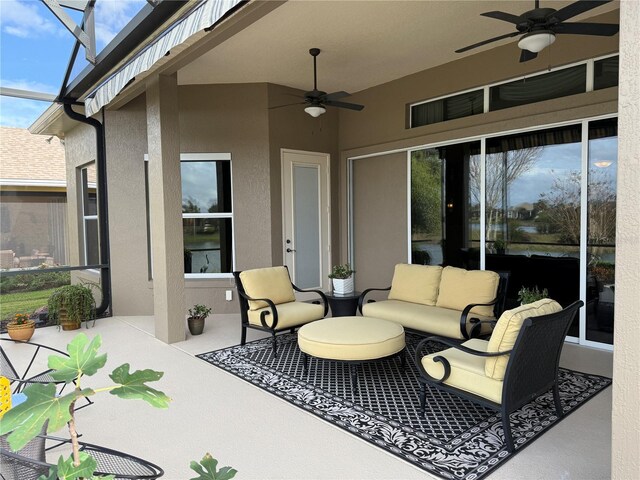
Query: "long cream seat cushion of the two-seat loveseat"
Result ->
[[362, 300, 489, 339]]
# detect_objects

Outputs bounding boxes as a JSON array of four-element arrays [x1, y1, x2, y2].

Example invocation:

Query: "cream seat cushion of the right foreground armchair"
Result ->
[[422, 338, 503, 403]]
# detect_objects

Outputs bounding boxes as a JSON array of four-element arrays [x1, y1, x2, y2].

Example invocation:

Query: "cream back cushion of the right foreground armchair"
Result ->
[[484, 298, 562, 380]]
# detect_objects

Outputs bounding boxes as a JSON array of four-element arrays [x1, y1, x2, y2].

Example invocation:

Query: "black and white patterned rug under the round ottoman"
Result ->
[[197, 333, 611, 480]]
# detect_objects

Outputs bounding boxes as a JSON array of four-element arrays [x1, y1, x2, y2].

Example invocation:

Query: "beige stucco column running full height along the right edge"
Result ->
[[611, 0, 640, 480]]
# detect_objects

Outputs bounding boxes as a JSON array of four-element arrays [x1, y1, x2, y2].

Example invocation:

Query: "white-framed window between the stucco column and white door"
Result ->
[[180, 154, 233, 275]]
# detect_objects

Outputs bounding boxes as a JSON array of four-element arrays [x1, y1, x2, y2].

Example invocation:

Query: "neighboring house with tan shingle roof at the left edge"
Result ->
[[0, 127, 68, 269]]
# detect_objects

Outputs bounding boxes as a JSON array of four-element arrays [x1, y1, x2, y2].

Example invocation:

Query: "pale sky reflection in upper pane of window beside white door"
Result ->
[[180, 162, 218, 213]]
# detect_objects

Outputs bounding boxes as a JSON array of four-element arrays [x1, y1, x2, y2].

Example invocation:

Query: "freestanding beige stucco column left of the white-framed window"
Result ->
[[147, 74, 185, 343]]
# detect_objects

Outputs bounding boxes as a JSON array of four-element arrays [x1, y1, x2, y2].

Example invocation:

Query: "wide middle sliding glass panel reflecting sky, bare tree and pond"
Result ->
[[485, 125, 582, 312]]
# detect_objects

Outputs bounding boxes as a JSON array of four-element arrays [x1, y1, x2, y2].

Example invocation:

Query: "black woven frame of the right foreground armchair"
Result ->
[[415, 300, 584, 453]]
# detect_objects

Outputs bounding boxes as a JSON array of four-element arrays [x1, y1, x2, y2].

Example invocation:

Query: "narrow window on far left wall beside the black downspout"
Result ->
[[80, 162, 100, 265]]
